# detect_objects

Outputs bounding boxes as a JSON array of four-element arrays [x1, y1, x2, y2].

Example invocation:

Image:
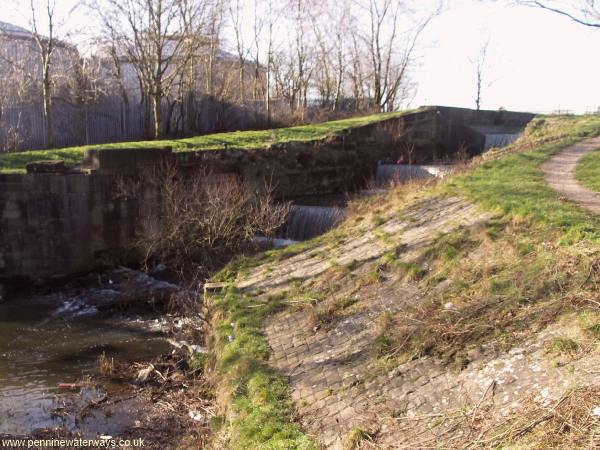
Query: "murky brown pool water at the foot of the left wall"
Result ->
[[0, 288, 168, 436]]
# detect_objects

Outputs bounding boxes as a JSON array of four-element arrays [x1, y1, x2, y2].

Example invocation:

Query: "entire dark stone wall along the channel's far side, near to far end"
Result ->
[[0, 107, 533, 280]]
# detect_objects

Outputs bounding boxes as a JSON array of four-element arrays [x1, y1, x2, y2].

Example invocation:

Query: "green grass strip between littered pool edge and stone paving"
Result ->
[[211, 288, 317, 450]]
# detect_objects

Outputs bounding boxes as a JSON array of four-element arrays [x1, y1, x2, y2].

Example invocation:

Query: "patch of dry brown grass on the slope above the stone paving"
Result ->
[[358, 215, 600, 369]]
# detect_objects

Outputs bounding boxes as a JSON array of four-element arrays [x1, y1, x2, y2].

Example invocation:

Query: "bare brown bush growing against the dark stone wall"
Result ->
[[121, 164, 290, 276]]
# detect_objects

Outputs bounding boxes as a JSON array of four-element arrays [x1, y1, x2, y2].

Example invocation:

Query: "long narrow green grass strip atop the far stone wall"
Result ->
[[0, 111, 410, 173]]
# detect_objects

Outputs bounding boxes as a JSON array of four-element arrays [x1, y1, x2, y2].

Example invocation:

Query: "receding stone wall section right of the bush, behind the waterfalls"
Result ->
[[174, 107, 534, 199]]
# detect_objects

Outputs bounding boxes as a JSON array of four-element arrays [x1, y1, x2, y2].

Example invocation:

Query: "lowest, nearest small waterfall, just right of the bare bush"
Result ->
[[278, 205, 346, 241]]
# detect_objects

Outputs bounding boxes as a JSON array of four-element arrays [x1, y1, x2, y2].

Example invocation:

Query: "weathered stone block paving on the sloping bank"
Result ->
[[238, 198, 600, 449]]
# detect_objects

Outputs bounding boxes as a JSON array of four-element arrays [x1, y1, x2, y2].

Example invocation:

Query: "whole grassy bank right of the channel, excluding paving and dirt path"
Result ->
[[200, 117, 600, 449]]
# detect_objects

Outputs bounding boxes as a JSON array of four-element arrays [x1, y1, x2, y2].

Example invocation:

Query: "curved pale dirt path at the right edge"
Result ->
[[542, 137, 600, 214]]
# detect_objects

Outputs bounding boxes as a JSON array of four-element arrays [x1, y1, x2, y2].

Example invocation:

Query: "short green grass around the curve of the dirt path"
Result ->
[[446, 116, 600, 244]]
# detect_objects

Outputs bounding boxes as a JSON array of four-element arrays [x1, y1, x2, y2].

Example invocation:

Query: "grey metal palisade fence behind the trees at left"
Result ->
[[0, 99, 283, 151]]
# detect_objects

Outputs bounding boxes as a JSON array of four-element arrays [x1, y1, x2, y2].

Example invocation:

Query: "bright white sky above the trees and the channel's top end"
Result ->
[[0, 0, 600, 112]]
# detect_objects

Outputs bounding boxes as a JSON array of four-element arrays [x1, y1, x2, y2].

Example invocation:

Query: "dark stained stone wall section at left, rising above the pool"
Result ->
[[0, 173, 155, 282]]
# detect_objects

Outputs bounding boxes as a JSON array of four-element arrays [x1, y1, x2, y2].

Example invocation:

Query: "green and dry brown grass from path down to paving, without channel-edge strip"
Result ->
[[354, 116, 600, 369]]
